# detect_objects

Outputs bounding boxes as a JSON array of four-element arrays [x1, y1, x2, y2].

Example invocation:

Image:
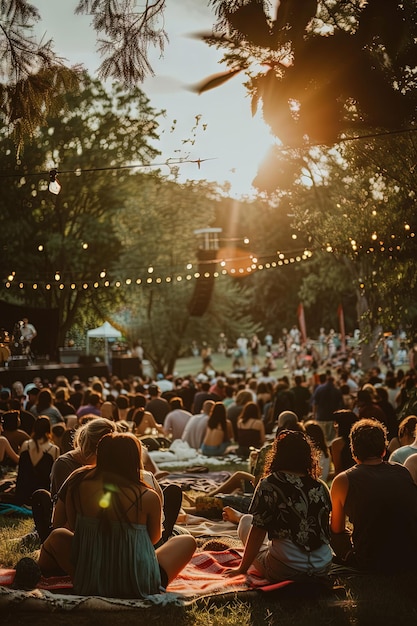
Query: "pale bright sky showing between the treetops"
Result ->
[[32, 0, 274, 197]]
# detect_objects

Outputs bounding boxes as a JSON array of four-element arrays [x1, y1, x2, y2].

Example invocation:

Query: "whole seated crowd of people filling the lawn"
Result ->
[[0, 326, 417, 597]]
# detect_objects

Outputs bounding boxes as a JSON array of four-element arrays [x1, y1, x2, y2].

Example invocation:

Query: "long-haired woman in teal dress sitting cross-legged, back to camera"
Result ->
[[39, 433, 196, 598]]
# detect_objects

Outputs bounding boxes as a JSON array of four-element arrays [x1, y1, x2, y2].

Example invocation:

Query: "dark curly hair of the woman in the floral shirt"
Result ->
[[264, 430, 320, 479]]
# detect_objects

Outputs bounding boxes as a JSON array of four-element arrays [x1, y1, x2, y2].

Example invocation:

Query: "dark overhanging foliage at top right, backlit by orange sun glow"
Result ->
[[205, 0, 417, 146]]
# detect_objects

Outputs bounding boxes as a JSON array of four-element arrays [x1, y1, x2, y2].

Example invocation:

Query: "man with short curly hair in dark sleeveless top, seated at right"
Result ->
[[331, 419, 417, 574]]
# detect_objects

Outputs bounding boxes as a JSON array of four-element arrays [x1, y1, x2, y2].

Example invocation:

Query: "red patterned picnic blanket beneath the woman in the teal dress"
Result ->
[[0, 548, 292, 611]]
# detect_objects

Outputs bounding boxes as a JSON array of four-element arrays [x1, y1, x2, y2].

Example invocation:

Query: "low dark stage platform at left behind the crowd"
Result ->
[[0, 363, 109, 387]]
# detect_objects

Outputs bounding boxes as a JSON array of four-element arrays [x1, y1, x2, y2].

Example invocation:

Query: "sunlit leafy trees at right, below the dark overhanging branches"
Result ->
[[260, 133, 417, 338]]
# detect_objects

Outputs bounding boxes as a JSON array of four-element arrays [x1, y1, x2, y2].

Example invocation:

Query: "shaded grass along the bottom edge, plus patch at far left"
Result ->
[[0, 504, 417, 626]]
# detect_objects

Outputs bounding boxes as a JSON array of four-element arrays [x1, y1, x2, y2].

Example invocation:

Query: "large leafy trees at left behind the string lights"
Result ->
[[0, 69, 270, 373]]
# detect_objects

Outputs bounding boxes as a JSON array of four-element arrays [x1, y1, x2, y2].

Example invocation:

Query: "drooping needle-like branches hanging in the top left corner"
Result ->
[[0, 0, 167, 153]]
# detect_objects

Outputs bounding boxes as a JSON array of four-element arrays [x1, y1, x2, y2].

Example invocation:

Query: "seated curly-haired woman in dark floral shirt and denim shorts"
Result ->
[[223, 430, 332, 582]]
